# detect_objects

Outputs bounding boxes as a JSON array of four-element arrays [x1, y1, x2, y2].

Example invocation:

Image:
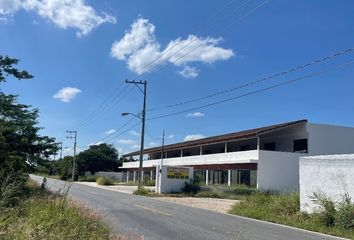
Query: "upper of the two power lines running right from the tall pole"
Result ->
[[147, 48, 354, 111]]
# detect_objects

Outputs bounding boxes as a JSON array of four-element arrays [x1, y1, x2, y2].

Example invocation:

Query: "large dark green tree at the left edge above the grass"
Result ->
[[0, 56, 58, 207]]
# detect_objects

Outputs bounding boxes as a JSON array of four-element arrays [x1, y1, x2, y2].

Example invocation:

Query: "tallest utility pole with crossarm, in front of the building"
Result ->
[[125, 80, 147, 189]]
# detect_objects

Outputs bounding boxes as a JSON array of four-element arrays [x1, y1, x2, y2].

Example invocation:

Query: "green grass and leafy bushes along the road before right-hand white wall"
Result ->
[[230, 192, 354, 239]]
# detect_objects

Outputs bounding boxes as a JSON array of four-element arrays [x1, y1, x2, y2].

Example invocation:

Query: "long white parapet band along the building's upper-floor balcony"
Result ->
[[121, 150, 258, 169]]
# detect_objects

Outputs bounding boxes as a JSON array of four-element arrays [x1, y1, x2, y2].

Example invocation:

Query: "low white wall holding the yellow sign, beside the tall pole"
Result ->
[[155, 165, 193, 193]]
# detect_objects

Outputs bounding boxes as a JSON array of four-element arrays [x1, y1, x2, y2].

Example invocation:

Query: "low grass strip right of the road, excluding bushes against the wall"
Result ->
[[230, 192, 354, 239]]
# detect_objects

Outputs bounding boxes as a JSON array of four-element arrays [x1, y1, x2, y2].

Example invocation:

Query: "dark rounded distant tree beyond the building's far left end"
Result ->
[[77, 143, 121, 175]]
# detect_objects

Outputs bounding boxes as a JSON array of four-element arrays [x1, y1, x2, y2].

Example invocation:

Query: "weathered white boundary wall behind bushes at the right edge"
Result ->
[[299, 154, 354, 212]]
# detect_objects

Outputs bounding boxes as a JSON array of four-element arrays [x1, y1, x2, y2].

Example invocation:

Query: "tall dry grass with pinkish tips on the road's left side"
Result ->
[[0, 182, 127, 240]]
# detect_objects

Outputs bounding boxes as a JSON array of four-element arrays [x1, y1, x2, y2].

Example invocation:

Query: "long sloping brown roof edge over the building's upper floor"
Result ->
[[123, 119, 307, 157]]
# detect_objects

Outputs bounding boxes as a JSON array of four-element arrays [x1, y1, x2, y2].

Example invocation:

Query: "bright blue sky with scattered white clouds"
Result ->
[[0, 0, 354, 157]]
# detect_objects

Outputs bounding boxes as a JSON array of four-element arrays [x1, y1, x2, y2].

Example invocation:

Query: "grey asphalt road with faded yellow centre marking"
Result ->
[[31, 175, 346, 240]]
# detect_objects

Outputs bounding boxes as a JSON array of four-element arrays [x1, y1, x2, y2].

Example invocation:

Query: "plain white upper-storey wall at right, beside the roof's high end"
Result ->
[[307, 123, 354, 155]]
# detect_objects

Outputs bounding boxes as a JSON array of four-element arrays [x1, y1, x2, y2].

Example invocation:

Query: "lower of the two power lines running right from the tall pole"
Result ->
[[147, 61, 354, 120]]
